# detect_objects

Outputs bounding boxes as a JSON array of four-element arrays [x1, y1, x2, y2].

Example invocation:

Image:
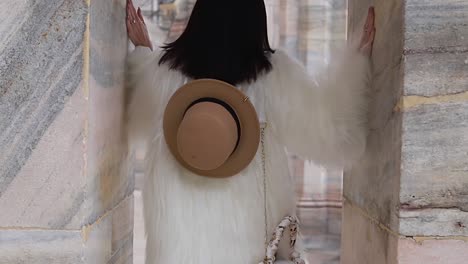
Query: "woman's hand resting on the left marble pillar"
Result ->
[[126, 0, 153, 50]]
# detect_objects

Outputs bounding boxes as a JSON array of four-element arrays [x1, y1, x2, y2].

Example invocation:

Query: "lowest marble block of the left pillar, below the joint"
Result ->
[[0, 196, 133, 264]]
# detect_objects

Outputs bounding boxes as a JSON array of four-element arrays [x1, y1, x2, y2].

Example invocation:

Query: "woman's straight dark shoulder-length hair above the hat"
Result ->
[[159, 0, 274, 85]]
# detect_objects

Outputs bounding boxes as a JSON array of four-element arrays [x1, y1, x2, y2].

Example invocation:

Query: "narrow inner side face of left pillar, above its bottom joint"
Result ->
[[74, 0, 134, 227]]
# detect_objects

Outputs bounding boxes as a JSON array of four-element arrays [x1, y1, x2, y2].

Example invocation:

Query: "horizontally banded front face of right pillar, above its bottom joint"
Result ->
[[400, 0, 468, 236]]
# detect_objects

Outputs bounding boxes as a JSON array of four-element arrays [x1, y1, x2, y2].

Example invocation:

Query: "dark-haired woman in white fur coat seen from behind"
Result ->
[[127, 0, 375, 264]]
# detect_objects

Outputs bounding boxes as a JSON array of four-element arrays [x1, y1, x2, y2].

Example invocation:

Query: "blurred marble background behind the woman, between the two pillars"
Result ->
[[134, 0, 346, 264]]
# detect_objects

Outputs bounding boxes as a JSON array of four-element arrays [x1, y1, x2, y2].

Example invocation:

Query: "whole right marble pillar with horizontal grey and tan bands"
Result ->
[[342, 0, 468, 264]]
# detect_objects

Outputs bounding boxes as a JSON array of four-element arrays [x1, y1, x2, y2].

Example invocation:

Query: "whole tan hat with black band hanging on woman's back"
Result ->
[[163, 79, 260, 178]]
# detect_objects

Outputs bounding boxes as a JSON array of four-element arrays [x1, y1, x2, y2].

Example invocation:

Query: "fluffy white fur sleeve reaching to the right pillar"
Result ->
[[266, 48, 370, 168]]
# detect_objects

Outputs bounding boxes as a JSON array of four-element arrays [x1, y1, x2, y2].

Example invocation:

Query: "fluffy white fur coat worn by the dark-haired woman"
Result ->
[[128, 44, 369, 264]]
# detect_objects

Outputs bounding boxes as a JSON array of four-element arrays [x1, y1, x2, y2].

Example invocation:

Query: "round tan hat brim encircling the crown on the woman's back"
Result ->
[[163, 79, 260, 178]]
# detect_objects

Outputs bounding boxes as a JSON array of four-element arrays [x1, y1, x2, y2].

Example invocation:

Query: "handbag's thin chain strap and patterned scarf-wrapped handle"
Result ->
[[259, 123, 306, 264]]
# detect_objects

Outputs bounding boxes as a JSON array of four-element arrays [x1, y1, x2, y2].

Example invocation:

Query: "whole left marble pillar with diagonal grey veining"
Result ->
[[0, 0, 133, 264]]
